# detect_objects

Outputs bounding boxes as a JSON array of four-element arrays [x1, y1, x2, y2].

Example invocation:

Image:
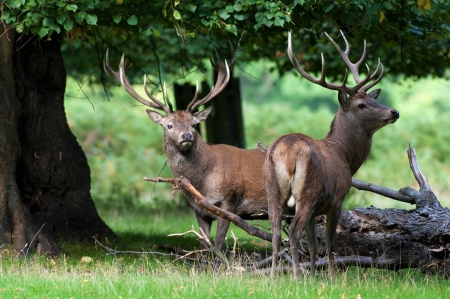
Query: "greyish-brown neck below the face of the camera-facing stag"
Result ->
[[164, 132, 214, 188]]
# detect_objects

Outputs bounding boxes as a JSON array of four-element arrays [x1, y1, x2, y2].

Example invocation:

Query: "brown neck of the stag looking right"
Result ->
[[323, 110, 374, 175]]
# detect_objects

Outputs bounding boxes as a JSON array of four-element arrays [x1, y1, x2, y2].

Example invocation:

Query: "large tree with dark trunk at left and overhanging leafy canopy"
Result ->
[[0, 0, 450, 254]]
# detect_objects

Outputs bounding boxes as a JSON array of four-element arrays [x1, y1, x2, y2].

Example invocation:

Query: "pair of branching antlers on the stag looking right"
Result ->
[[288, 31, 384, 95]]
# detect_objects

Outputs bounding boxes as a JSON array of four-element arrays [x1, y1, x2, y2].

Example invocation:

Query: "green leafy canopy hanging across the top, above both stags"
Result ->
[[0, 0, 450, 81]]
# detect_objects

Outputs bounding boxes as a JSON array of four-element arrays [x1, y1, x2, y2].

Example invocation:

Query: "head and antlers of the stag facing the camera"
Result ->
[[104, 51, 230, 151]]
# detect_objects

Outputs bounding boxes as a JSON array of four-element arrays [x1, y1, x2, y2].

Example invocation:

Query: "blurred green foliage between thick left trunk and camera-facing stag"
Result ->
[[65, 81, 176, 210]]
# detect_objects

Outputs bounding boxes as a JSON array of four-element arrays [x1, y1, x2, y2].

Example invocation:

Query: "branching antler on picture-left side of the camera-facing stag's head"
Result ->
[[103, 49, 168, 113]]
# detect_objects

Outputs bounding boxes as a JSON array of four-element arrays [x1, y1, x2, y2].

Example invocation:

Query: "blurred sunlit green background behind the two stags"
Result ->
[[65, 58, 450, 218]]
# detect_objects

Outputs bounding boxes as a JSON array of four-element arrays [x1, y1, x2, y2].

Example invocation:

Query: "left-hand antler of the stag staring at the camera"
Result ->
[[103, 49, 173, 114]]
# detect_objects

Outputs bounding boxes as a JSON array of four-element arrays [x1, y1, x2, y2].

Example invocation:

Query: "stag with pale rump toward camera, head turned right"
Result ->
[[263, 32, 400, 277]]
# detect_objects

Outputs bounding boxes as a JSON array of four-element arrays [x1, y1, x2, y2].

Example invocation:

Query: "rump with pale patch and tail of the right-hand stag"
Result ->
[[263, 133, 351, 217]]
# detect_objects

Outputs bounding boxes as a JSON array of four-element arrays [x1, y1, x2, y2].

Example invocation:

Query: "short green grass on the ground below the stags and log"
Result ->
[[0, 209, 450, 299]]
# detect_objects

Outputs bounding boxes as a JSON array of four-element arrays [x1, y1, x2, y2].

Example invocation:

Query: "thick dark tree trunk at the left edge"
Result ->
[[0, 30, 114, 254]]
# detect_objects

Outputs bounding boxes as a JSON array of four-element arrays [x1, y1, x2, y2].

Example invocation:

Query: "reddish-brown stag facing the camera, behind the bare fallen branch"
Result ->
[[105, 52, 267, 249]]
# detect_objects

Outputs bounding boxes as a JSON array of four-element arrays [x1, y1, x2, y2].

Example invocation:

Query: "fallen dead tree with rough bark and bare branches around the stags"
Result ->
[[144, 148, 450, 276]]
